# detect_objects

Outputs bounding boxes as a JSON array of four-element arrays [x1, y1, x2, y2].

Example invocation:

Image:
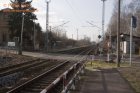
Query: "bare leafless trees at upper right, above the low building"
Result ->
[[107, 0, 140, 36]]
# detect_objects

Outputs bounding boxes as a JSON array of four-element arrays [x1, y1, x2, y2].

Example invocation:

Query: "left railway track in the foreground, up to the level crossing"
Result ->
[[0, 60, 62, 90]]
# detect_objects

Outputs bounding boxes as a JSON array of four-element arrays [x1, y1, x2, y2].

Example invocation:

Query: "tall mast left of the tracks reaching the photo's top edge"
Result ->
[[45, 0, 50, 52]]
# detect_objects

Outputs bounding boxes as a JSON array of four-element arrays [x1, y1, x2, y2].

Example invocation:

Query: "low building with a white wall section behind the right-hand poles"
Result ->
[[108, 33, 140, 54]]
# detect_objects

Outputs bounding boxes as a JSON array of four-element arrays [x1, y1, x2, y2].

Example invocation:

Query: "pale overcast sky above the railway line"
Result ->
[[0, 0, 129, 41]]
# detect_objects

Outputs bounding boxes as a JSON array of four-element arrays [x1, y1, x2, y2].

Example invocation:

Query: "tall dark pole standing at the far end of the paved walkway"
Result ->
[[117, 0, 121, 67]]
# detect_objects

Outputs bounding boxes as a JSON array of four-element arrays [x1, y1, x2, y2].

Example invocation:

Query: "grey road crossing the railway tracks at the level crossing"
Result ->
[[0, 49, 140, 63]]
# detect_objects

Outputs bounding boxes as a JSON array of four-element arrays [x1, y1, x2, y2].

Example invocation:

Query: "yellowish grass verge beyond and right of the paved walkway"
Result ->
[[86, 61, 140, 93]]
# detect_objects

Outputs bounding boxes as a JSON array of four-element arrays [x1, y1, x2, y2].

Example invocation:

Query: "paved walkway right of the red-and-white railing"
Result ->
[[71, 69, 134, 93]]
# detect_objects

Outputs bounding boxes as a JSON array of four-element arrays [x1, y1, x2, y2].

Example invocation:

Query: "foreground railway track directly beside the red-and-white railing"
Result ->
[[7, 61, 74, 93]]
